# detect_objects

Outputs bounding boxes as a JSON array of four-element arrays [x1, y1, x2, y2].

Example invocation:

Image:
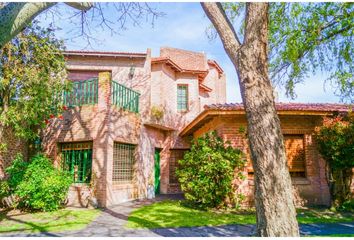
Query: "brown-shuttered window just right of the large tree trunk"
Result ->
[[284, 135, 306, 177]]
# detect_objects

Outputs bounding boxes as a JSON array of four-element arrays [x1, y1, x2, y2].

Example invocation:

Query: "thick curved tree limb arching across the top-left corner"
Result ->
[[0, 2, 93, 48]]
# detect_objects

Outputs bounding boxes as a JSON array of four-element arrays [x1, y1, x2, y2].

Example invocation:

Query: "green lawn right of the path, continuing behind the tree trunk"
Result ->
[[127, 200, 354, 228]]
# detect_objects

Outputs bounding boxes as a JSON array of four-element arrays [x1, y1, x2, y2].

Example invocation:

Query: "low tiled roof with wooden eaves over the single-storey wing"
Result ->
[[180, 103, 353, 136]]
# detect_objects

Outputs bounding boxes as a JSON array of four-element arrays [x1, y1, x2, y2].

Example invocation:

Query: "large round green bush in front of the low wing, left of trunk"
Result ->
[[176, 132, 246, 208]]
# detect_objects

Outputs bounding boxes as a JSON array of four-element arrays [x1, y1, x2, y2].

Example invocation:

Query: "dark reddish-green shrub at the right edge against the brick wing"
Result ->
[[316, 116, 354, 208]]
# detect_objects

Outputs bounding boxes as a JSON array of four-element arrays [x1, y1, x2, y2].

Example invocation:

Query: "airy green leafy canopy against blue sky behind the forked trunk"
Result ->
[[223, 2, 354, 102]]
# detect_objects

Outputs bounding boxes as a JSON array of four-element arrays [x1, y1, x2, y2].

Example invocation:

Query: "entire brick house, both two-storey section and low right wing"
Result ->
[[42, 47, 348, 206]]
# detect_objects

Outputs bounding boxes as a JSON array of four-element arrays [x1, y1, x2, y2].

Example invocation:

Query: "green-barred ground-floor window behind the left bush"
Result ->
[[61, 142, 92, 183]]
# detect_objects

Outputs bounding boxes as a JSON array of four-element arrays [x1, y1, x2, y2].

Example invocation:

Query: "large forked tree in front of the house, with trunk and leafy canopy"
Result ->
[[202, 3, 354, 236]]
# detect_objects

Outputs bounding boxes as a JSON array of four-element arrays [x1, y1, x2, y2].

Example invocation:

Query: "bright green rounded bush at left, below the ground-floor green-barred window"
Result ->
[[6, 154, 72, 211]]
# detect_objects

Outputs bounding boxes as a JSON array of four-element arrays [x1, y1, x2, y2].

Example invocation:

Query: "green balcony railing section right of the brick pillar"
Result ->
[[112, 81, 140, 113]]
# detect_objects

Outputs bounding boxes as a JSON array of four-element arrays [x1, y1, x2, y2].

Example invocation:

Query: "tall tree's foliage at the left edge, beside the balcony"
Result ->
[[0, 22, 66, 139]]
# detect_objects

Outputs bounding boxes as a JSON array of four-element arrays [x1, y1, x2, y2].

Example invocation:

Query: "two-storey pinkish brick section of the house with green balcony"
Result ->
[[42, 48, 226, 206]]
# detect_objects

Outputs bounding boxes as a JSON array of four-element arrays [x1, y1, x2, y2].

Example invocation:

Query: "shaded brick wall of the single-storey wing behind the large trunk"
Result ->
[[194, 115, 330, 205]]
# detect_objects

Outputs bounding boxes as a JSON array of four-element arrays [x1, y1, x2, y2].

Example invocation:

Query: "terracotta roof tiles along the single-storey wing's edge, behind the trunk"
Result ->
[[204, 103, 353, 112]]
